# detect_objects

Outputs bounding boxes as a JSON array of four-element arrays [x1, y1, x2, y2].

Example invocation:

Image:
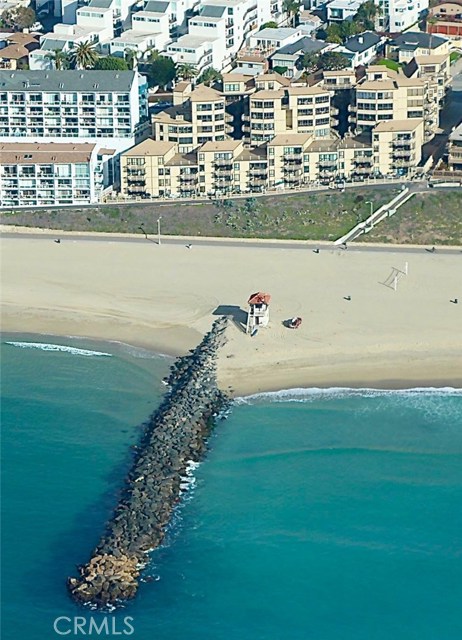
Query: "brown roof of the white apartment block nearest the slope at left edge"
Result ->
[[0, 142, 95, 164]]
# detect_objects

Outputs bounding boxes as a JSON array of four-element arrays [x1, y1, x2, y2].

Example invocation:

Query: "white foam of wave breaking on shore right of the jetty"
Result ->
[[235, 387, 462, 404]]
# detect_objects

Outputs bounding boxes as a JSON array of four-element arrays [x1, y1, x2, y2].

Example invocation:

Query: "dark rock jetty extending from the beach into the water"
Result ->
[[68, 317, 228, 607]]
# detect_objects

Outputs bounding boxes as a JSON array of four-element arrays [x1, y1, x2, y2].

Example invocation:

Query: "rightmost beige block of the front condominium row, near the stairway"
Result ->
[[372, 118, 424, 176]]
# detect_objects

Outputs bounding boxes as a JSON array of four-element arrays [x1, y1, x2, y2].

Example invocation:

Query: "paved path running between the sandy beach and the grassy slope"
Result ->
[[1, 232, 462, 259]]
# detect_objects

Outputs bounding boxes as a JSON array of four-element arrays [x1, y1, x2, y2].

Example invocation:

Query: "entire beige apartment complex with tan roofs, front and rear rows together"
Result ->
[[121, 54, 450, 198]]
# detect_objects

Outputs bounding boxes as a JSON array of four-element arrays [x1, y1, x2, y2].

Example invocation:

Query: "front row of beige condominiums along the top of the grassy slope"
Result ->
[[117, 128, 406, 198]]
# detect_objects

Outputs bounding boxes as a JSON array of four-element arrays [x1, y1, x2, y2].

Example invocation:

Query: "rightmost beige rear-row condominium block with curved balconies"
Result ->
[[350, 66, 441, 140]]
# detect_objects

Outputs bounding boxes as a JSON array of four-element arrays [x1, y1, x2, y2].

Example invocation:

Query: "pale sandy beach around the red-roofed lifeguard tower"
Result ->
[[1, 225, 462, 395]]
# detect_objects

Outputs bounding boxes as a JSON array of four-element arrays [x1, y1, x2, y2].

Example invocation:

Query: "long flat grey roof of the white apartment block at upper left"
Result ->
[[0, 70, 136, 91]]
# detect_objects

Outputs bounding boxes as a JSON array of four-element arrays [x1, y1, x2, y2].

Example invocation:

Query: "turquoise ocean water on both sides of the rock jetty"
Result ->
[[1, 336, 462, 640]]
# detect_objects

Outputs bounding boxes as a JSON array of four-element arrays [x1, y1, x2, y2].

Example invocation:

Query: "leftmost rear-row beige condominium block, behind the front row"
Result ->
[[152, 83, 227, 153]]
